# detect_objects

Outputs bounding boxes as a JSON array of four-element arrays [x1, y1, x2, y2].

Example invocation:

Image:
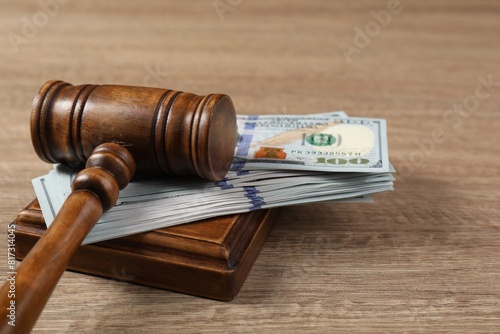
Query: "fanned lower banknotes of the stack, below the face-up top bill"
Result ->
[[33, 166, 393, 244]]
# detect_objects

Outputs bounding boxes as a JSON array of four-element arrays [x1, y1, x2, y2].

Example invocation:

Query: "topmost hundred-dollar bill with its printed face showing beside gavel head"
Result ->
[[232, 113, 390, 173]]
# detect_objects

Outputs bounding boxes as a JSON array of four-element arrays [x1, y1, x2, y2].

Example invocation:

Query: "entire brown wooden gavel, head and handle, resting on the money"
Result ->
[[0, 81, 237, 333]]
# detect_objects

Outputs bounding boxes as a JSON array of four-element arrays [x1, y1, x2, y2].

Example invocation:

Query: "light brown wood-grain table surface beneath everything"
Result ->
[[0, 0, 500, 333]]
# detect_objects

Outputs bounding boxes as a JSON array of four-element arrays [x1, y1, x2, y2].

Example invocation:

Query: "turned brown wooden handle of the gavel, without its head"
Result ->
[[0, 143, 135, 333]]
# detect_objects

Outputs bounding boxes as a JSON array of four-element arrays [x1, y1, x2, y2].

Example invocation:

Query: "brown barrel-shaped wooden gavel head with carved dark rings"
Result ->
[[31, 81, 237, 180]]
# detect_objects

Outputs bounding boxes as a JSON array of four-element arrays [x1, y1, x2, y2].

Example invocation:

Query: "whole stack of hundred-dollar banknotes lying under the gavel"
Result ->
[[33, 112, 394, 244]]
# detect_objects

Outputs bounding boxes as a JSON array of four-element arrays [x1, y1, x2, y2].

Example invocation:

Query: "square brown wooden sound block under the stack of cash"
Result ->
[[14, 199, 278, 301]]
